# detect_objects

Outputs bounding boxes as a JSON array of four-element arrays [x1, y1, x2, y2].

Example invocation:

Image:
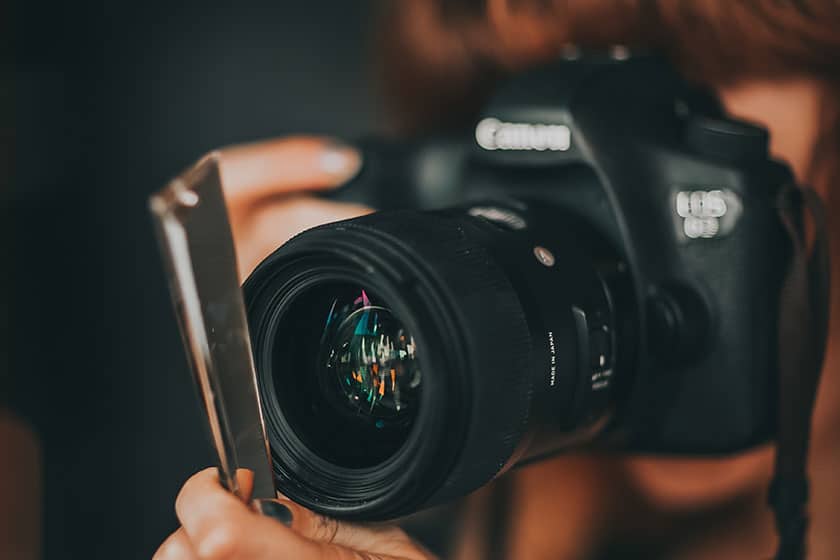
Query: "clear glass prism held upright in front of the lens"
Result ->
[[149, 154, 275, 498]]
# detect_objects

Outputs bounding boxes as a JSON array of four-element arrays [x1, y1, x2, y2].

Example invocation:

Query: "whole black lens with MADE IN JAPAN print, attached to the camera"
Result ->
[[244, 209, 616, 520]]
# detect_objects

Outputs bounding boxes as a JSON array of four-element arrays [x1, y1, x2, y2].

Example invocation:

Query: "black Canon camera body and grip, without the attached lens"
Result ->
[[332, 54, 793, 454]]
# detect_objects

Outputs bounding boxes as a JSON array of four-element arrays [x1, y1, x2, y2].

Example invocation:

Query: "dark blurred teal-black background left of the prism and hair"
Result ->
[[9, 0, 398, 559]]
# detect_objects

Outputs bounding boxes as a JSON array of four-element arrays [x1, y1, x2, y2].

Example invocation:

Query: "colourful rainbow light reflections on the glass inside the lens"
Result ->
[[321, 290, 421, 428]]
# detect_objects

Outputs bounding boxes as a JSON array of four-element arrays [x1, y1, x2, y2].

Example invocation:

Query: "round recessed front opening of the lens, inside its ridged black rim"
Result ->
[[272, 281, 422, 468]]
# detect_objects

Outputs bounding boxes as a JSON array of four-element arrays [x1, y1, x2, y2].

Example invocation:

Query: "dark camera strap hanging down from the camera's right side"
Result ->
[[768, 188, 831, 560]]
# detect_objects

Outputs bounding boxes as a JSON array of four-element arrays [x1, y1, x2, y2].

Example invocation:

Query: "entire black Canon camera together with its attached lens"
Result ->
[[245, 57, 793, 519]]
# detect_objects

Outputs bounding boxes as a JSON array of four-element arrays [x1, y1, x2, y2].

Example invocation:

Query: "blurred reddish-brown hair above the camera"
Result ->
[[378, 0, 840, 320]]
